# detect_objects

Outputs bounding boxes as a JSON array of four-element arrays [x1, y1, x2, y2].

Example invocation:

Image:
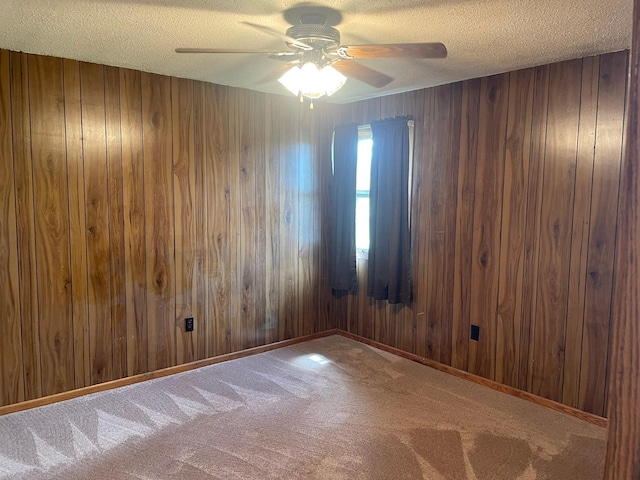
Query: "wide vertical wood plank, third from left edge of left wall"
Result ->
[[29, 56, 75, 395]]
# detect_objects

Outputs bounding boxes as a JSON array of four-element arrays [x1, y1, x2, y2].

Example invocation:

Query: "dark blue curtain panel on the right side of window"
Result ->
[[367, 117, 411, 303]]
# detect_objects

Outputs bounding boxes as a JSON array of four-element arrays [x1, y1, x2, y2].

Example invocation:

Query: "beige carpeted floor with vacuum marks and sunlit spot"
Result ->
[[0, 336, 605, 480]]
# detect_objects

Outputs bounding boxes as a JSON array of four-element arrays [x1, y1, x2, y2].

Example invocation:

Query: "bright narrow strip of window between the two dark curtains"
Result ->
[[356, 125, 373, 253]]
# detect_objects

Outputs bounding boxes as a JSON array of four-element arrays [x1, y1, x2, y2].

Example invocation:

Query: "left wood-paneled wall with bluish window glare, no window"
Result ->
[[0, 50, 326, 405]]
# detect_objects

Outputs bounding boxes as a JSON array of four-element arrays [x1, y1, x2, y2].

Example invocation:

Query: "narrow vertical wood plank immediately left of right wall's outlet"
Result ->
[[450, 79, 480, 370]]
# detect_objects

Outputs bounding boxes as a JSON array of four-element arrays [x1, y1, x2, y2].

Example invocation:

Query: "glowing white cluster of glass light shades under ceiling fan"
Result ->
[[278, 62, 347, 100]]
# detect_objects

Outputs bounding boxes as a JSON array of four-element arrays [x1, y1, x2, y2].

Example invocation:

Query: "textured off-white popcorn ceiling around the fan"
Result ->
[[0, 0, 632, 103]]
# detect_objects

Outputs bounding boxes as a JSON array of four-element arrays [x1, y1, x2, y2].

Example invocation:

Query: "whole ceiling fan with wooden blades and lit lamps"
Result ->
[[175, 8, 447, 108]]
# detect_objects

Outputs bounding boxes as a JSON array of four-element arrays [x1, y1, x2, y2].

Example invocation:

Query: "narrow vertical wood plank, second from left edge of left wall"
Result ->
[[10, 52, 42, 400]]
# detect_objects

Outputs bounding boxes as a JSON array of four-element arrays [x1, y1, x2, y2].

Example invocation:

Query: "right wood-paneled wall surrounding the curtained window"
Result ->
[[318, 52, 627, 415]]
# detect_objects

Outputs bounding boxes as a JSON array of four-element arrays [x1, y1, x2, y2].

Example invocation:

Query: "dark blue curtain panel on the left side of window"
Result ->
[[329, 124, 358, 295]]
